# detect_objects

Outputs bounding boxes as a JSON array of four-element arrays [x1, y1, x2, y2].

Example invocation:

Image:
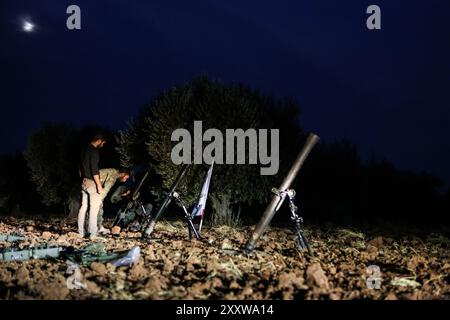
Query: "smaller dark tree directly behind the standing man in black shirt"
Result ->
[[25, 124, 118, 215]]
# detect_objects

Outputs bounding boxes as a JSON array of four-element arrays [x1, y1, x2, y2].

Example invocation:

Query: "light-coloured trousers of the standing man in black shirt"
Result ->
[[78, 179, 102, 236]]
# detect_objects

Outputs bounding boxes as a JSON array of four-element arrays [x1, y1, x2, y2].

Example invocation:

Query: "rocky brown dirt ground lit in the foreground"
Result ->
[[0, 217, 450, 300]]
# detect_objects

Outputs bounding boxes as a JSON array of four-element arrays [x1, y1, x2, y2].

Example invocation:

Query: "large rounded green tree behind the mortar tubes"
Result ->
[[118, 77, 302, 224]]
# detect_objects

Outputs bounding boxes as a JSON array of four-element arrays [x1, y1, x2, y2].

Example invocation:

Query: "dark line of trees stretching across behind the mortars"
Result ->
[[0, 77, 450, 226]]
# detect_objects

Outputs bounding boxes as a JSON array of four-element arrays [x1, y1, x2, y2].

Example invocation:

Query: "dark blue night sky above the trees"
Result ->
[[0, 0, 450, 182]]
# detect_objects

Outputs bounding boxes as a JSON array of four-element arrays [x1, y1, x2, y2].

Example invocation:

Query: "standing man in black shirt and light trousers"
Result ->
[[78, 133, 106, 239]]
